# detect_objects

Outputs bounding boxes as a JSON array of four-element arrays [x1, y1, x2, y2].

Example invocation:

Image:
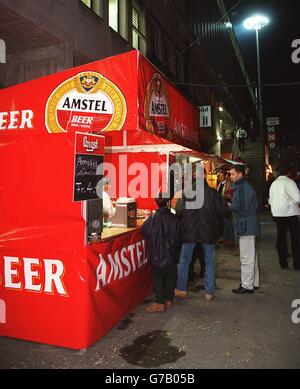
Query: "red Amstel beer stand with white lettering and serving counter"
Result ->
[[0, 51, 204, 349]]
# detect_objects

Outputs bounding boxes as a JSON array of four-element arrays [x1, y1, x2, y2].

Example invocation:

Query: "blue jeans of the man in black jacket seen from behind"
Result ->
[[176, 243, 216, 294]]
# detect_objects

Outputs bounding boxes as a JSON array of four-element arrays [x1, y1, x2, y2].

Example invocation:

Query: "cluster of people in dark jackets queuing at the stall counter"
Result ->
[[141, 165, 259, 313]]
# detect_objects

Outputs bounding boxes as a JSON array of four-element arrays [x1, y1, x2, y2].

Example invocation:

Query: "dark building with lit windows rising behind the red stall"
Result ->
[[0, 0, 255, 157]]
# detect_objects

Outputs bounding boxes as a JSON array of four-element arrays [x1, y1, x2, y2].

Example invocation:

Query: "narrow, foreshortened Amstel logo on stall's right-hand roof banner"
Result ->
[[145, 74, 172, 140]]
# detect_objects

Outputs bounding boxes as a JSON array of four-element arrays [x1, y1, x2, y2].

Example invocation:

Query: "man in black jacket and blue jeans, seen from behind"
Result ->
[[175, 172, 230, 301]]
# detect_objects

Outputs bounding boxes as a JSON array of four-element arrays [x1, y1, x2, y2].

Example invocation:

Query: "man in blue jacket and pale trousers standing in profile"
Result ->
[[230, 165, 259, 294]]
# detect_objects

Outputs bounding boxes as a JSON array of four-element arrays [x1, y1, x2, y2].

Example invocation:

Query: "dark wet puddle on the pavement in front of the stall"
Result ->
[[119, 330, 186, 368]]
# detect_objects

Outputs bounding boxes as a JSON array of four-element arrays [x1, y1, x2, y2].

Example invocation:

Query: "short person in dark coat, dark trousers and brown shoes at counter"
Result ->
[[141, 193, 181, 313]]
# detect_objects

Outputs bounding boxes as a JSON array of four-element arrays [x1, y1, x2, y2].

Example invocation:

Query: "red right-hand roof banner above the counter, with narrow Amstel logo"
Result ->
[[138, 56, 200, 150]]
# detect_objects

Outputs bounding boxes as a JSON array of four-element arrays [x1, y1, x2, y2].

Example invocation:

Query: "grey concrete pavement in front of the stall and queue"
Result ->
[[0, 214, 300, 369]]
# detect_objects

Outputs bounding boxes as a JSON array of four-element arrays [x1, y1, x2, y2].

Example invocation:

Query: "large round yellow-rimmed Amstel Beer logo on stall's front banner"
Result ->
[[46, 72, 127, 133]]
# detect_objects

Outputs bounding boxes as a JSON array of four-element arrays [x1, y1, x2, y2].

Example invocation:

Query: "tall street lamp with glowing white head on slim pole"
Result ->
[[243, 15, 269, 135]]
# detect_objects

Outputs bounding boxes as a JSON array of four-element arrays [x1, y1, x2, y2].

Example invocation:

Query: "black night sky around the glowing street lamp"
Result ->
[[225, 0, 300, 139]]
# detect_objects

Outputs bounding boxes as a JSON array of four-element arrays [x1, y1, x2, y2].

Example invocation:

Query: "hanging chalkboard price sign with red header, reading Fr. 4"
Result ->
[[73, 133, 104, 201]]
